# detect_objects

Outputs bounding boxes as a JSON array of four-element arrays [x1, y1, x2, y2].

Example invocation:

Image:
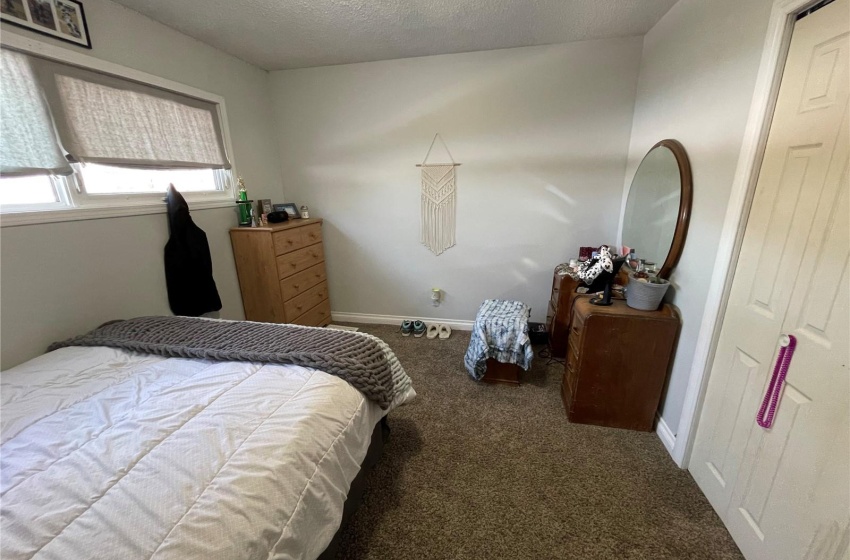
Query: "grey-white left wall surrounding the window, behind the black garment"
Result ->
[[0, 0, 282, 369]]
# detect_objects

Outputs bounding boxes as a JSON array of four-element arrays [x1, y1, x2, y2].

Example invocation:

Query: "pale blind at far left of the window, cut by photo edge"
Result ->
[[0, 49, 73, 175]]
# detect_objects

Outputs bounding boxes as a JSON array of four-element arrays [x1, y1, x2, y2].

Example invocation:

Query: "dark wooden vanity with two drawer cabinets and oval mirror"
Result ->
[[549, 138, 693, 431]]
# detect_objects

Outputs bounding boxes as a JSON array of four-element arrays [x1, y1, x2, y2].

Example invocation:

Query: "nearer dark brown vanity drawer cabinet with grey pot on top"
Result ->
[[561, 296, 680, 431]]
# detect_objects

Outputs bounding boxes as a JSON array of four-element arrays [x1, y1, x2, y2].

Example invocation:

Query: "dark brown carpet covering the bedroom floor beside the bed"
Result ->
[[339, 325, 742, 560]]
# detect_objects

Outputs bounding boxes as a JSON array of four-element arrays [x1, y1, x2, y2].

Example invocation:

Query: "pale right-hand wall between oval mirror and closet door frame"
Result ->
[[626, 0, 772, 434]]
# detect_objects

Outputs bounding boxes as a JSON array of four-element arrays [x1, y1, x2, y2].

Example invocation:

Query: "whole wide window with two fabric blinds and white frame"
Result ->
[[0, 37, 234, 225]]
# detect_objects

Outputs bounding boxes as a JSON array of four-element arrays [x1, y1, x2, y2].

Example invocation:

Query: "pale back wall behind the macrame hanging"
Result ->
[[271, 37, 641, 321]]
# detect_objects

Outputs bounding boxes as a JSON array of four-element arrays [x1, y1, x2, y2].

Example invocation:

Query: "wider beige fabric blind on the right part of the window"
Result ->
[[35, 59, 230, 169]]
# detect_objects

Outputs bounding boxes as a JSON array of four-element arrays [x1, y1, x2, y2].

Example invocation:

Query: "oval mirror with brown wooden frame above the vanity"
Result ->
[[621, 140, 692, 278]]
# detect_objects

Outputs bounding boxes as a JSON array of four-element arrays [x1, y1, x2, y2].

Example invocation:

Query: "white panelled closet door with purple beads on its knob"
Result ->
[[690, 0, 850, 560]]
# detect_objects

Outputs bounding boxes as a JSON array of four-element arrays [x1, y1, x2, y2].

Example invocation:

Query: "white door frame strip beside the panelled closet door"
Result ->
[[671, 0, 820, 469]]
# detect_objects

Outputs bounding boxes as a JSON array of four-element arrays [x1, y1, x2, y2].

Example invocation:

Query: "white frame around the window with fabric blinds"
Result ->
[[0, 33, 236, 227]]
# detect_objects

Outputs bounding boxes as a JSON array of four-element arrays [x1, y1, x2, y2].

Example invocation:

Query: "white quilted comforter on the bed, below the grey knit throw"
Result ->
[[0, 347, 412, 560]]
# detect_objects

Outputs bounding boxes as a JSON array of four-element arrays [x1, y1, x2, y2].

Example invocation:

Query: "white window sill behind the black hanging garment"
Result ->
[[0, 199, 234, 228]]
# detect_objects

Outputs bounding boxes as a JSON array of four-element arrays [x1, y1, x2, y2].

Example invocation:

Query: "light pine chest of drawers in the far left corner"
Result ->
[[230, 219, 331, 326]]
